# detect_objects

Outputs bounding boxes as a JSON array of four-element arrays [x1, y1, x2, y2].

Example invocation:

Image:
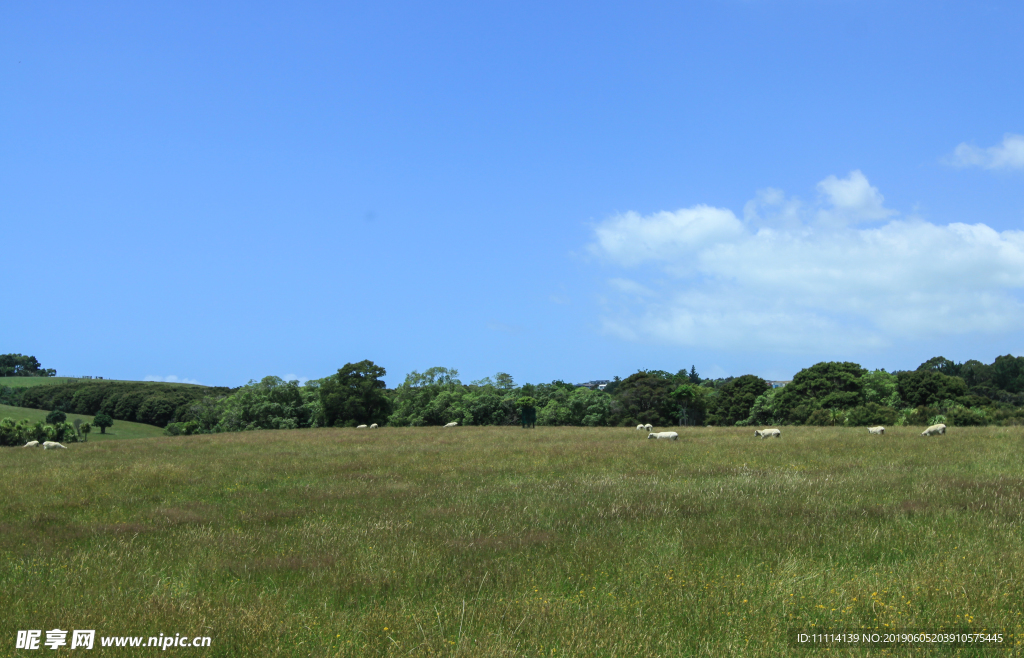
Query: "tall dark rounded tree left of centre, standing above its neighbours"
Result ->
[[319, 360, 393, 427]]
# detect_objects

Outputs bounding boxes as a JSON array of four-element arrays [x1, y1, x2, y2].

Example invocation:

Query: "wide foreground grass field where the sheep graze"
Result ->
[[0, 428, 1024, 657]]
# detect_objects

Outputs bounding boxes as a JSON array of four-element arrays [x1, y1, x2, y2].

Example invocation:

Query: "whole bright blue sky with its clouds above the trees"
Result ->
[[0, 0, 1024, 386]]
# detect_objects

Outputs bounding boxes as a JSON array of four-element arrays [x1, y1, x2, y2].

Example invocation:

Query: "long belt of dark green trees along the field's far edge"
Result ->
[[0, 355, 1024, 435]]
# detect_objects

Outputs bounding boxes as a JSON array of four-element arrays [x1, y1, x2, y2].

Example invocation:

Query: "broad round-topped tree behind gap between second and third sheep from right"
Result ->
[[776, 361, 867, 422]]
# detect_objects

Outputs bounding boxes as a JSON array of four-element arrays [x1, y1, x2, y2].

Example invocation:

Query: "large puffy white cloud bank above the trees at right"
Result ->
[[590, 172, 1024, 353]]
